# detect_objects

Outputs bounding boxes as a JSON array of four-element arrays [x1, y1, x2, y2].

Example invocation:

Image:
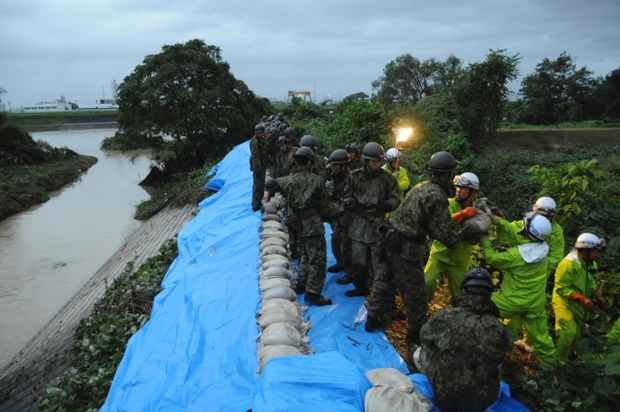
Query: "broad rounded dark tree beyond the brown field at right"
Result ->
[[520, 52, 598, 124]]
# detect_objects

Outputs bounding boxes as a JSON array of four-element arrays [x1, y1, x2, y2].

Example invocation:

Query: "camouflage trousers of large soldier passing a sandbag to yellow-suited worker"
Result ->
[[366, 243, 427, 343]]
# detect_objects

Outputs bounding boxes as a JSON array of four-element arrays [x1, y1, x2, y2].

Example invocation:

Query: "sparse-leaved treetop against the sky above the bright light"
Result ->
[[372, 54, 461, 106]]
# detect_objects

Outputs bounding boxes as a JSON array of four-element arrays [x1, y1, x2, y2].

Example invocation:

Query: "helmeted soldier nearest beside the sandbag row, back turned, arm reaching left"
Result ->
[[269, 147, 333, 306]]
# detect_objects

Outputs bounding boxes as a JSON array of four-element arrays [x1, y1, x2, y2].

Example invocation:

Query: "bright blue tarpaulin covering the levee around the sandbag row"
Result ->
[[101, 142, 519, 412]]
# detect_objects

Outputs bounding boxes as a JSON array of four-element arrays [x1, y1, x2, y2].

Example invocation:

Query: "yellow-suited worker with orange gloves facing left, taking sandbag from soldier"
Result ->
[[424, 172, 480, 302]]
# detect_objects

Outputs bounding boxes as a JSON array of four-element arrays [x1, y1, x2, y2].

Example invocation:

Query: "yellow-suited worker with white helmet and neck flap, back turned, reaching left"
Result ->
[[480, 212, 557, 369]]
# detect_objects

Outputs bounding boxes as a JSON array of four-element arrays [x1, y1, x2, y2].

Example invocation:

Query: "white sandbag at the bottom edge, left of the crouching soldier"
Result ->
[[364, 368, 433, 412]]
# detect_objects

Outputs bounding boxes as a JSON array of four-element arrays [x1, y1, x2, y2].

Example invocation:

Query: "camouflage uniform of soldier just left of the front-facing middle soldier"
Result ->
[[329, 164, 352, 270]]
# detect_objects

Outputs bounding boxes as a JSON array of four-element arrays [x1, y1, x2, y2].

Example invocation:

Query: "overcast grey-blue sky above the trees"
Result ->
[[0, 0, 620, 110]]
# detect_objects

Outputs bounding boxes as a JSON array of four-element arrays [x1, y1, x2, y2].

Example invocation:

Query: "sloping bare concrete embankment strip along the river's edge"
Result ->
[[0, 206, 196, 412]]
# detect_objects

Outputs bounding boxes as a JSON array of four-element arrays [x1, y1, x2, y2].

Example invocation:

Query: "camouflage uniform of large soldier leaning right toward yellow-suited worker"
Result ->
[[367, 177, 461, 344]]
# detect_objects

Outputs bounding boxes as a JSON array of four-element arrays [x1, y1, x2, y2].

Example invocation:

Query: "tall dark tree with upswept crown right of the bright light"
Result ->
[[450, 50, 520, 151]]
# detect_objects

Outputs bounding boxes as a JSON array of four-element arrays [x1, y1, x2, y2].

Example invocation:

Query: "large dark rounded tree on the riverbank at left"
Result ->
[[114, 39, 272, 177]]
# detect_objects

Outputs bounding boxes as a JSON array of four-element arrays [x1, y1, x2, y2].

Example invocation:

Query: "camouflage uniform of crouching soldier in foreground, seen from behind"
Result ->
[[420, 295, 508, 411]]
